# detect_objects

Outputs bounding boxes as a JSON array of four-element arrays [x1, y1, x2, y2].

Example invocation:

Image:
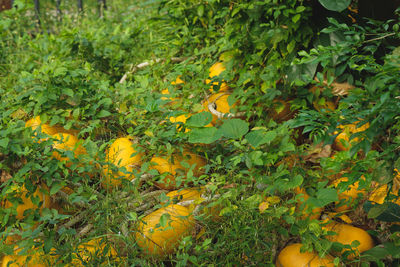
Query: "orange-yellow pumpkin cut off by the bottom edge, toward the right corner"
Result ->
[[275, 243, 335, 267]]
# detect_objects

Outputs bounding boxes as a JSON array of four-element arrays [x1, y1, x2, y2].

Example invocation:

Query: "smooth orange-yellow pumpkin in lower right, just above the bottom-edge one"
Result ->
[[324, 222, 374, 259]]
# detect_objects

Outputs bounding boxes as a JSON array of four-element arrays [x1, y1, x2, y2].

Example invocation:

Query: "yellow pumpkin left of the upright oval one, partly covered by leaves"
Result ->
[[52, 133, 86, 167]]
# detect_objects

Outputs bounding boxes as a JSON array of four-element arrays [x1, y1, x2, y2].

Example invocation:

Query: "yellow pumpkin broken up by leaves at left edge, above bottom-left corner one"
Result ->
[[3, 185, 51, 220]]
